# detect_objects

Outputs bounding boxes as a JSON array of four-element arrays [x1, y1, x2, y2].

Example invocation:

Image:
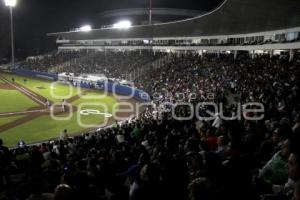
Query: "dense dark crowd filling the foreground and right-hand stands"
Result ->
[[0, 54, 300, 200]]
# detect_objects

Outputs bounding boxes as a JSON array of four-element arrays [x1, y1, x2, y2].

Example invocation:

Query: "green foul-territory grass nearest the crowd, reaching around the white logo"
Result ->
[[0, 93, 117, 147]]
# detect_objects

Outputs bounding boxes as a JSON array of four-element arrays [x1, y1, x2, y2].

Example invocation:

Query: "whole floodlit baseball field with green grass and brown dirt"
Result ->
[[0, 73, 125, 147]]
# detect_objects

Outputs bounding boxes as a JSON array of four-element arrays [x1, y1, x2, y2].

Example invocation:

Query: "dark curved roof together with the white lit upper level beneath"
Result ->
[[48, 0, 299, 58]]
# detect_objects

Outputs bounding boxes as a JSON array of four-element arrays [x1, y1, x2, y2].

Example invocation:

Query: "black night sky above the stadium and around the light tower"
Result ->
[[0, 0, 221, 61]]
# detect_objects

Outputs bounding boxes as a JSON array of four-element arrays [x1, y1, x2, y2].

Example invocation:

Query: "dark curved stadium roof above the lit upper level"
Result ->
[[48, 0, 300, 40]]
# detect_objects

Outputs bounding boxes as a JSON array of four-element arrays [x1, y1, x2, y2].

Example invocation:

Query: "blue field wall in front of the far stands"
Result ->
[[12, 69, 150, 102]]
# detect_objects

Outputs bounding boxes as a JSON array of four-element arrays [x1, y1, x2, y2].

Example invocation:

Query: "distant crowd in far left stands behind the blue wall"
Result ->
[[21, 50, 162, 79]]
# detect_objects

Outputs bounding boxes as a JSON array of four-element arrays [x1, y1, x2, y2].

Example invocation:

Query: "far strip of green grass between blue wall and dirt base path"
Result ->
[[1, 73, 80, 102]]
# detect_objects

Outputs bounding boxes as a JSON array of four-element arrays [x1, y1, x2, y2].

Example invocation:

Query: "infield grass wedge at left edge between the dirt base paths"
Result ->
[[0, 89, 38, 112]]
